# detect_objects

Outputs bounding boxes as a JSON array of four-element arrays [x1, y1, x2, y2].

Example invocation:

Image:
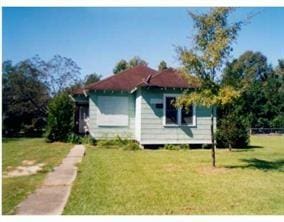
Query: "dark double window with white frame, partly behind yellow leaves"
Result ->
[[164, 95, 195, 126]]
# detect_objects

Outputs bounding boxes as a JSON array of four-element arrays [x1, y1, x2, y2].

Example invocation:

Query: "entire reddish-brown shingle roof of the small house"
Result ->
[[73, 65, 196, 94]]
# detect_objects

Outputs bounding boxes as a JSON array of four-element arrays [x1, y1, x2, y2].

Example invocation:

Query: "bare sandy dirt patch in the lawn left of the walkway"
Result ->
[[3, 160, 45, 178]]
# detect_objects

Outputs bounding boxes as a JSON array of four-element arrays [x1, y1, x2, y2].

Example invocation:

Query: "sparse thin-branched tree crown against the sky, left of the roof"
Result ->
[[33, 55, 81, 96]]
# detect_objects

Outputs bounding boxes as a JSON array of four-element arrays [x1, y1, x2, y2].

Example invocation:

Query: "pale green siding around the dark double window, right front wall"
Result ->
[[140, 89, 214, 144]]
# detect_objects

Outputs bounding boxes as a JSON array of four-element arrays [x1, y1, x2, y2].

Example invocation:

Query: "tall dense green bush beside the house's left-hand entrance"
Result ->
[[46, 92, 75, 142]]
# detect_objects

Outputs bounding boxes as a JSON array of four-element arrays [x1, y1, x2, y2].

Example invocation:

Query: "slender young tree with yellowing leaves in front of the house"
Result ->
[[176, 8, 242, 167]]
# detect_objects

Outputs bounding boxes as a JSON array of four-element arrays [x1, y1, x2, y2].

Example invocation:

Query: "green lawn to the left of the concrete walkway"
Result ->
[[2, 138, 72, 214]]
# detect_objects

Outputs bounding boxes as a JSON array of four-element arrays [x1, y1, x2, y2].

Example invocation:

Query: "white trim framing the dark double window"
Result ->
[[163, 94, 196, 127]]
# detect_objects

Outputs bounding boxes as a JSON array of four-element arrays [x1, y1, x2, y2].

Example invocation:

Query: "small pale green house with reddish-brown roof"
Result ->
[[73, 65, 216, 145]]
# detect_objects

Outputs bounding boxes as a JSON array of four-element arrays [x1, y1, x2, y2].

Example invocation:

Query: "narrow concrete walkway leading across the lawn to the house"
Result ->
[[16, 145, 85, 215]]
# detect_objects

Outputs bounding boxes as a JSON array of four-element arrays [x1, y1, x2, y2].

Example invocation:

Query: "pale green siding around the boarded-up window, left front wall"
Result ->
[[89, 92, 135, 139]]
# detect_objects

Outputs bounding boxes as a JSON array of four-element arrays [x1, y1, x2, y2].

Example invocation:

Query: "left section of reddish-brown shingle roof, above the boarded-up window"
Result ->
[[85, 65, 158, 91]]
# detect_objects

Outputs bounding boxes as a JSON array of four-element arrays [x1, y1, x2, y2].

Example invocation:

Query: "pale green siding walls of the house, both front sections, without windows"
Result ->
[[86, 88, 216, 144]]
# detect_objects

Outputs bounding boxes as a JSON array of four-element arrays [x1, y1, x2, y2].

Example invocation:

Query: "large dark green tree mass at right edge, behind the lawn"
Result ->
[[222, 51, 284, 128]]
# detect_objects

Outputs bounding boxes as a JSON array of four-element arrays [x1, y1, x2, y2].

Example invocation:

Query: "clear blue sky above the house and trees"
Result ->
[[2, 7, 284, 77]]
